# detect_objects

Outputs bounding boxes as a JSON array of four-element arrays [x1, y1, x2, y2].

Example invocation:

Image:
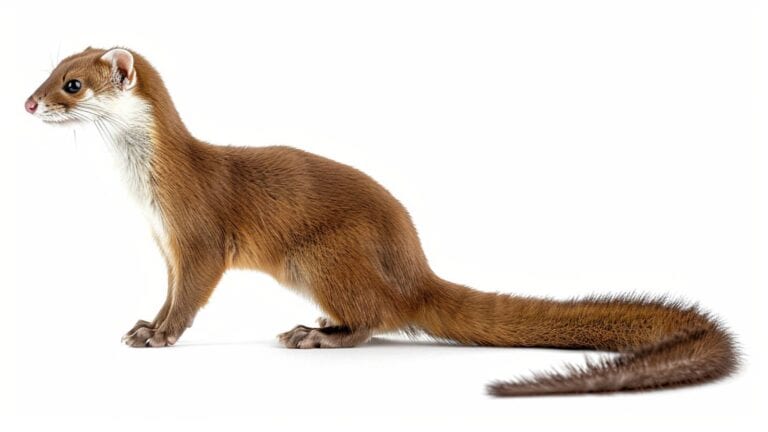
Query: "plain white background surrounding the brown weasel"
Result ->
[[0, 0, 768, 431]]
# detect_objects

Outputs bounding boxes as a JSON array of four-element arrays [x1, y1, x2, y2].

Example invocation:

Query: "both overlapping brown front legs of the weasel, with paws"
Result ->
[[124, 248, 225, 347]]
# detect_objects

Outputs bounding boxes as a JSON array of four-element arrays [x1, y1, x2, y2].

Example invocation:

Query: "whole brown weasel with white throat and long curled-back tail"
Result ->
[[25, 47, 739, 396]]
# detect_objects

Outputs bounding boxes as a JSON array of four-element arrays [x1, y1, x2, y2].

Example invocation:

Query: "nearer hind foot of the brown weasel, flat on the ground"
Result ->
[[278, 325, 372, 349]]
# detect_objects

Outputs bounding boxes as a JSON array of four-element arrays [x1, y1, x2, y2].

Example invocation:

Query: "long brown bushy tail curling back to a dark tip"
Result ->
[[417, 280, 739, 396]]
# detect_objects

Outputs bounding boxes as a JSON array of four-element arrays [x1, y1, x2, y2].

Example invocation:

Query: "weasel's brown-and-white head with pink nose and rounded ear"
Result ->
[[24, 47, 139, 123]]
